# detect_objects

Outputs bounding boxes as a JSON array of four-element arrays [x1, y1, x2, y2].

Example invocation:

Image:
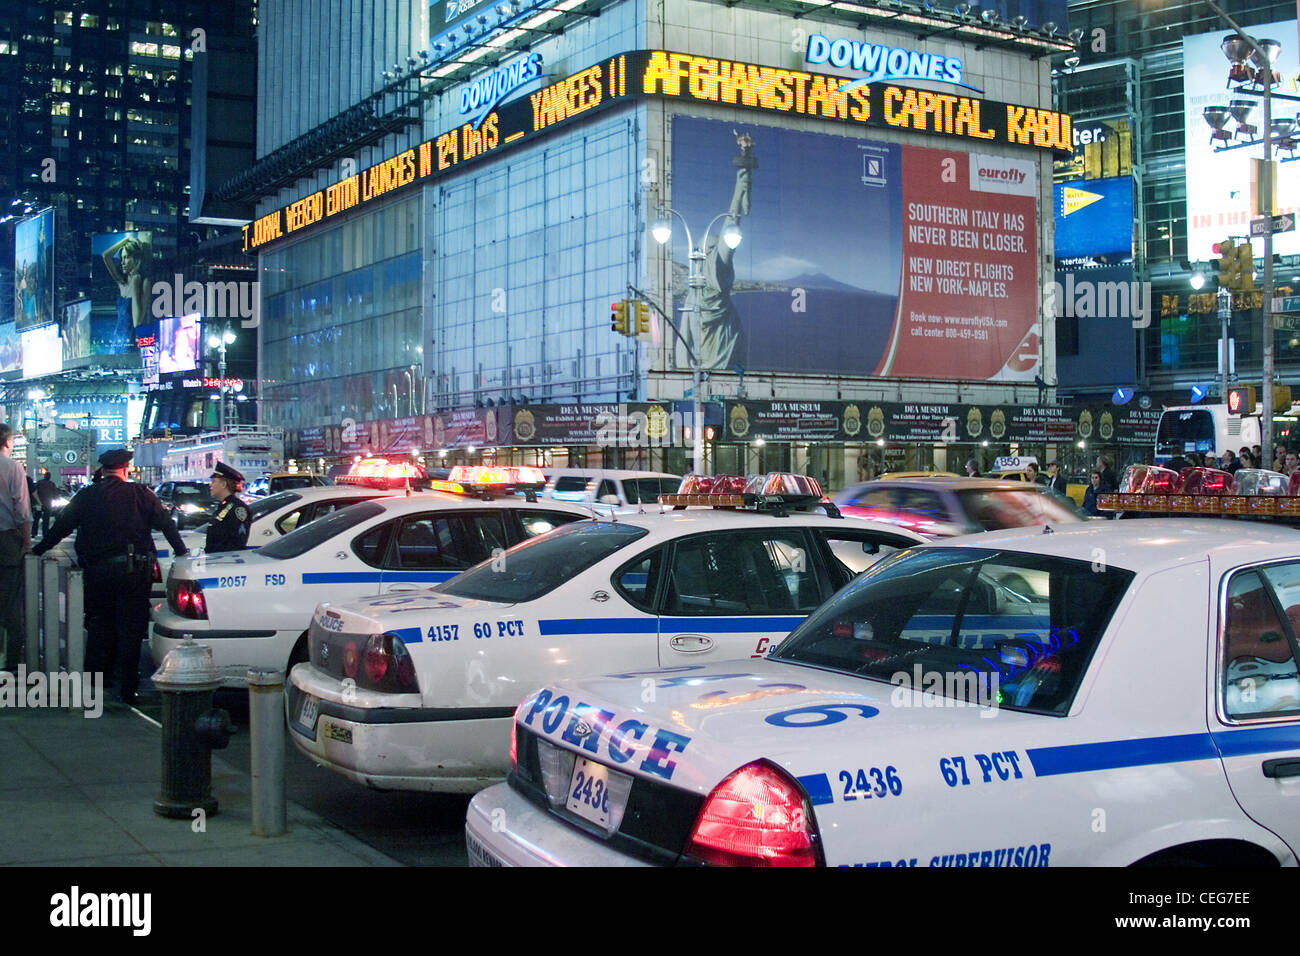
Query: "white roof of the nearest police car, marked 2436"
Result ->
[[935, 518, 1300, 571]]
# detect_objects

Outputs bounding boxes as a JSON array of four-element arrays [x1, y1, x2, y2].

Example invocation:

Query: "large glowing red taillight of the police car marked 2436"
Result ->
[[685, 760, 819, 866]]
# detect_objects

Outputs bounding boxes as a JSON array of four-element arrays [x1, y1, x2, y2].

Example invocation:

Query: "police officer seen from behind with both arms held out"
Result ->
[[31, 449, 186, 704]]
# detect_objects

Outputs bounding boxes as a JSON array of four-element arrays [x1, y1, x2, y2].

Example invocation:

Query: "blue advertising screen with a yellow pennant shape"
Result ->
[[1053, 176, 1134, 268]]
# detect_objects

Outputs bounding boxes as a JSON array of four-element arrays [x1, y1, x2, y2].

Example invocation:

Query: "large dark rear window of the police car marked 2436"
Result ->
[[772, 548, 1134, 715]]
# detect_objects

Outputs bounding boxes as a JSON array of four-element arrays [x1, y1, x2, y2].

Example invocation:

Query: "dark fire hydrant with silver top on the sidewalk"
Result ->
[[153, 640, 235, 819]]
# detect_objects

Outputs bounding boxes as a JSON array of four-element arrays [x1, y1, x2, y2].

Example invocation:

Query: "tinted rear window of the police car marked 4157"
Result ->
[[434, 522, 650, 604]]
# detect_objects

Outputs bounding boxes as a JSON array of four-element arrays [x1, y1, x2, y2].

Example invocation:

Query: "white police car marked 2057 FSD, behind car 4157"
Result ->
[[151, 468, 590, 685]]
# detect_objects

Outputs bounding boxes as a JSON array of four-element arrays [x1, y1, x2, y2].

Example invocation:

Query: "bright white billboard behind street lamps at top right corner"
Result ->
[[1183, 20, 1300, 261]]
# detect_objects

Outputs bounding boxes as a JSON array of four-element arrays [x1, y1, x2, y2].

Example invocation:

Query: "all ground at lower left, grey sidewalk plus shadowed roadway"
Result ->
[[0, 650, 468, 866]]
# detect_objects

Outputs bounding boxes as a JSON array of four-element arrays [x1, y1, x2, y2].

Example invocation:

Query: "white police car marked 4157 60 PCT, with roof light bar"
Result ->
[[286, 475, 922, 792]]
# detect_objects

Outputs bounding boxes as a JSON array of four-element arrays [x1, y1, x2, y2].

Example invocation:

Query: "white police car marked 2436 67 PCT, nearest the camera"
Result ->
[[467, 519, 1300, 866]]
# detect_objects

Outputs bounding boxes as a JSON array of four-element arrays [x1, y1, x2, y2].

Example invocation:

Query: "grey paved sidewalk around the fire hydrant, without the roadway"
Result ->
[[0, 708, 399, 866]]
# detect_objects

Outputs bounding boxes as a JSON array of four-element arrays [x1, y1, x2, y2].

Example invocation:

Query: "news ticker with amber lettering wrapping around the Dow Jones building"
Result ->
[[243, 49, 1074, 252]]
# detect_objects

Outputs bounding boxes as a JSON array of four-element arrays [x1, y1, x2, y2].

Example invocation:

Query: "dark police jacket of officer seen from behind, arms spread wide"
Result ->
[[31, 475, 186, 567]]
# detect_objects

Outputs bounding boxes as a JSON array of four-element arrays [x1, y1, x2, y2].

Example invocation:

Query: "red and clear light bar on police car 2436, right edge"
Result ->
[[1097, 464, 1300, 518]]
